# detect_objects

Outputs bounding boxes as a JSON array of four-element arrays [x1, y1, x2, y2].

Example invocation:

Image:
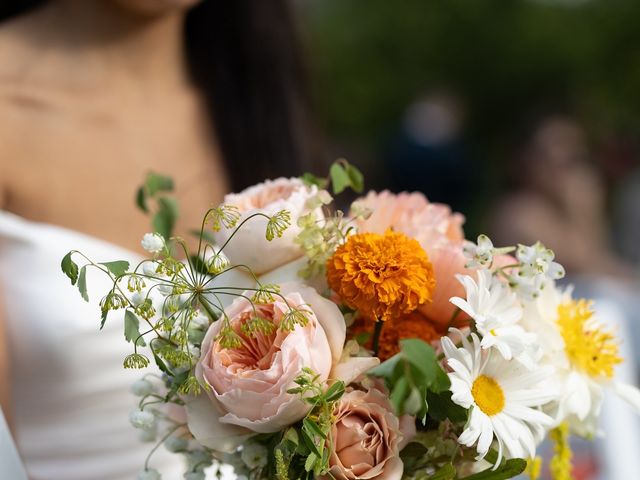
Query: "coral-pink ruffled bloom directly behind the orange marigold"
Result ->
[[358, 190, 476, 330]]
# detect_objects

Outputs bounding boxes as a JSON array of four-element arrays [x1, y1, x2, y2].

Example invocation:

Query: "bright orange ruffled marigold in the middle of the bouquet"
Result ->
[[327, 230, 435, 320]]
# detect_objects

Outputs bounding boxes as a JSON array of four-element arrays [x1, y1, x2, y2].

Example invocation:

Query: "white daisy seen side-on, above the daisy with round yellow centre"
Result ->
[[450, 270, 536, 365]]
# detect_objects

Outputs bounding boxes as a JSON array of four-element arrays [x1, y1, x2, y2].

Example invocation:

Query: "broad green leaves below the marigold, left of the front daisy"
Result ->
[[369, 338, 450, 422]]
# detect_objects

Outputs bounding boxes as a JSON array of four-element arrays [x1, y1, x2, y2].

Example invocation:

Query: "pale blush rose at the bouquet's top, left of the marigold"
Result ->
[[215, 178, 322, 275]]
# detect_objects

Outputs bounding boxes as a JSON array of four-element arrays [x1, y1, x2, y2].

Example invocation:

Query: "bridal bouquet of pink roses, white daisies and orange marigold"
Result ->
[[62, 161, 640, 480]]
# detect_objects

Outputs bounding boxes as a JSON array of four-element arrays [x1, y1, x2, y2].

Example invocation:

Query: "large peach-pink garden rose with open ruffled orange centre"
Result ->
[[187, 283, 377, 451]]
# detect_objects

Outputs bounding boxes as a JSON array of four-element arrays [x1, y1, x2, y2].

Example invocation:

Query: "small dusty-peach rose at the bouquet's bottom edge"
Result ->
[[325, 388, 404, 480]]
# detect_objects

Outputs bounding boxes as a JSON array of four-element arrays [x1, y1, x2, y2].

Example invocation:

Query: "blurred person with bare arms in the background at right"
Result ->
[[490, 116, 632, 278]]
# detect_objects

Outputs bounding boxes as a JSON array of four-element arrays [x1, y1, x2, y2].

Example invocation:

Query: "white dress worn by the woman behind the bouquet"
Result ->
[[0, 210, 184, 480]]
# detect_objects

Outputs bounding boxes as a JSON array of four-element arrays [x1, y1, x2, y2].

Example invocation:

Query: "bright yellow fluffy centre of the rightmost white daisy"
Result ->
[[557, 299, 622, 378]]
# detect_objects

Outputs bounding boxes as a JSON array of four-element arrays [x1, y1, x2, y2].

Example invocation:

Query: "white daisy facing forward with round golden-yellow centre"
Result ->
[[441, 329, 555, 465]]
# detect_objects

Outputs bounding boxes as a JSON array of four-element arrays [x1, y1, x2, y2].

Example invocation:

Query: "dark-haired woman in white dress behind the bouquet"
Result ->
[[0, 0, 316, 480]]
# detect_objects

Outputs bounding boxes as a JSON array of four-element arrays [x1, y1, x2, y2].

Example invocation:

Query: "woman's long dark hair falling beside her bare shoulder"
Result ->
[[0, 0, 316, 189]]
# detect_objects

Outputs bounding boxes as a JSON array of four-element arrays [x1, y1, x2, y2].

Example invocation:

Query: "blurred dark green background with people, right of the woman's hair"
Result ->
[[297, 0, 640, 479]]
